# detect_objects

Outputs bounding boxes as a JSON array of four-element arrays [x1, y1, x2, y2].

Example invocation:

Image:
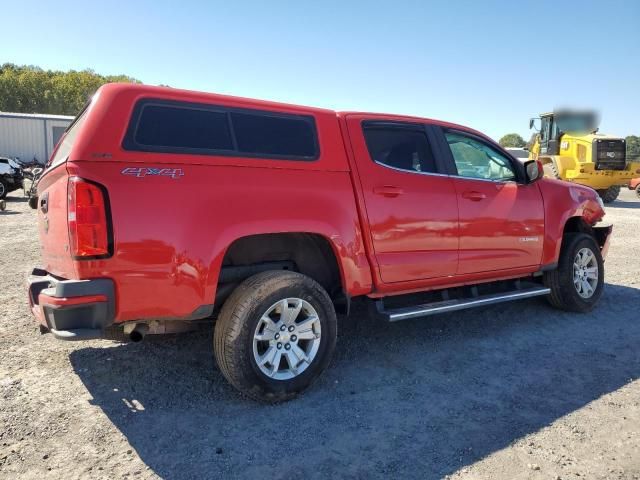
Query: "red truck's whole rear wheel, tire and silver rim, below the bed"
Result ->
[[214, 271, 337, 402]]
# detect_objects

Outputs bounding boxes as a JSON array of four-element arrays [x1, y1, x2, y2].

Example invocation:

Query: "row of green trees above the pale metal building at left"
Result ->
[[0, 63, 140, 115]]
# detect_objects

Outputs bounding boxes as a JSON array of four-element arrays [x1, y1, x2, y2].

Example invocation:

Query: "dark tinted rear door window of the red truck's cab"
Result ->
[[363, 123, 437, 173]]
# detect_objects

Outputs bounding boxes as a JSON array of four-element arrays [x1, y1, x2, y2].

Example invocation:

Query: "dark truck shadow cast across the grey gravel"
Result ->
[[71, 284, 640, 479]]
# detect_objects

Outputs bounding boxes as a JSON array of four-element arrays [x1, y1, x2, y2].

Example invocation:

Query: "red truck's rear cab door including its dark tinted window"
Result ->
[[347, 115, 458, 283]]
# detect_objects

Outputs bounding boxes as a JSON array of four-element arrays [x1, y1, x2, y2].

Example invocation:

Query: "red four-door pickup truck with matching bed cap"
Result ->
[[28, 84, 611, 401]]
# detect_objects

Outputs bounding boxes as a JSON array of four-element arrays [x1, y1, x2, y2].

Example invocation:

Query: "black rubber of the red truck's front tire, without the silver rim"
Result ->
[[544, 233, 604, 313]]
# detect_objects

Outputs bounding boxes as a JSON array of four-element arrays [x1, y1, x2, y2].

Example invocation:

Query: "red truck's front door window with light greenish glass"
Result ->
[[445, 132, 516, 181]]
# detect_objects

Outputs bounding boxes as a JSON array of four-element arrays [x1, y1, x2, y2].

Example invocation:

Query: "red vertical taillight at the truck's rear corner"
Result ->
[[68, 177, 112, 259]]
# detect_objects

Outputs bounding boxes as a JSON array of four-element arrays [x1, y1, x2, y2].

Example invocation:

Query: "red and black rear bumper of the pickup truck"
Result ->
[[27, 268, 115, 340]]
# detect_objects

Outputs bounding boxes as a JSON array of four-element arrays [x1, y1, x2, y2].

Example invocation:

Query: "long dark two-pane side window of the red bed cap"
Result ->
[[123, 100, 319, 160]]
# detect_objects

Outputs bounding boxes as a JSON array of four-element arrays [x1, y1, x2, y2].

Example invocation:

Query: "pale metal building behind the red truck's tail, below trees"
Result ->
[[0, 112, 73, 163]]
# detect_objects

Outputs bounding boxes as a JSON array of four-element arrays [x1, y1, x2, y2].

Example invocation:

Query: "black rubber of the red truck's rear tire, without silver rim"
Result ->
[[214, 271, 337, 403]]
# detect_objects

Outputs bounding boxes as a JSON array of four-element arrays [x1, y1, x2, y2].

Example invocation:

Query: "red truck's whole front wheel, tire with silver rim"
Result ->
[[544, 233, 604, 312]]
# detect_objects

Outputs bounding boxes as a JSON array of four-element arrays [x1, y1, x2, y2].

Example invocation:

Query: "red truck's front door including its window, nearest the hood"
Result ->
[[444, 130, 544, 275]]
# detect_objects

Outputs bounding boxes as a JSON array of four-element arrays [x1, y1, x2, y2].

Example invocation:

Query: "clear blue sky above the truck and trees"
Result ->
[[0, 0, 640, 139]]
